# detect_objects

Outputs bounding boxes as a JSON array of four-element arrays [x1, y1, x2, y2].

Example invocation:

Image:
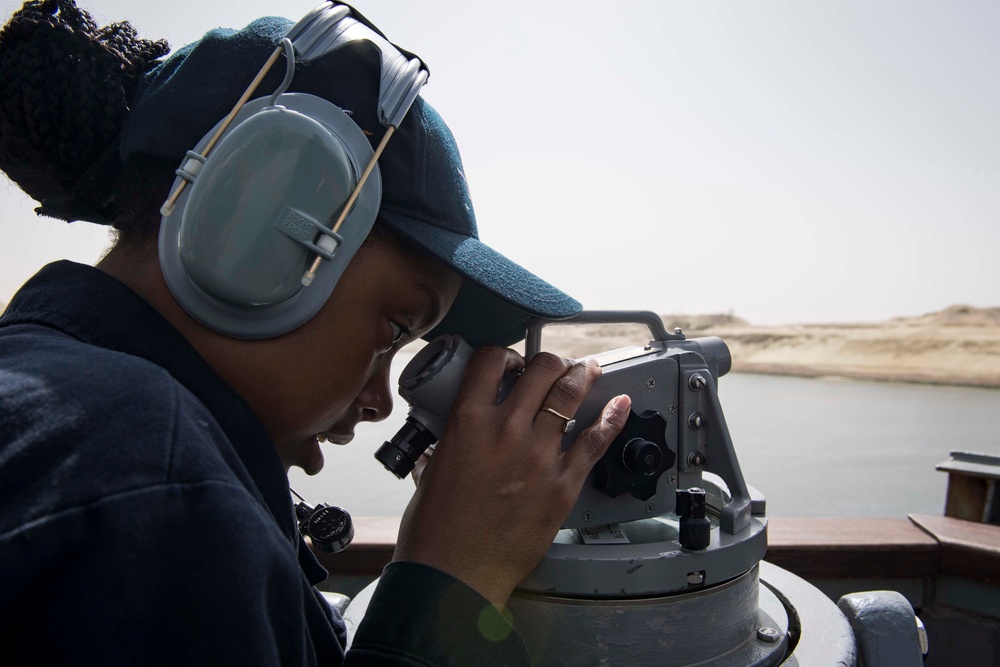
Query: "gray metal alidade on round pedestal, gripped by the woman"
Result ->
[[354, 311, 922, 667]]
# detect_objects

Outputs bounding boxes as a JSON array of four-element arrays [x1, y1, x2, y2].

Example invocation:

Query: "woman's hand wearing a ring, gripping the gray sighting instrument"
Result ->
[[394, 347, 631, 607]]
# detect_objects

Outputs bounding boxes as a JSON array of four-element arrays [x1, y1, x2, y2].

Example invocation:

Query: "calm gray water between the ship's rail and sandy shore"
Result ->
[[289, 354, 1000, 517]]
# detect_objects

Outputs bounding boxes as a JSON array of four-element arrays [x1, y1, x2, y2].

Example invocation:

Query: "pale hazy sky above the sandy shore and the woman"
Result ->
[[0, 0, 1000, 324]]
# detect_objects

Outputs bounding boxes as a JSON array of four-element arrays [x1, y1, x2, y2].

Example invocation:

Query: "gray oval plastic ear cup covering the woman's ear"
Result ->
[[159, 93, 382, 339]]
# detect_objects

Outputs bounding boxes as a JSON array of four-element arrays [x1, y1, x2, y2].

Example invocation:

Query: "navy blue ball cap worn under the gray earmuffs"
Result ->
[[121, 13, 581, 346]]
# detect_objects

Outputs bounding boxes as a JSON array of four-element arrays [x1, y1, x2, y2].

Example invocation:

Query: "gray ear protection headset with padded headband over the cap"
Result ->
[[159, 2, 428, 339]]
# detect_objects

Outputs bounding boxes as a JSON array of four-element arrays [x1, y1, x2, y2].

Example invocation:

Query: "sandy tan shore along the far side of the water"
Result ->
[[543, 306, 1000, 388]]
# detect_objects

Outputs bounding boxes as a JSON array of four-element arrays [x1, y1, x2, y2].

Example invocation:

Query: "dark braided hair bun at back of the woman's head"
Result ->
[[0, 0, 169, 227]]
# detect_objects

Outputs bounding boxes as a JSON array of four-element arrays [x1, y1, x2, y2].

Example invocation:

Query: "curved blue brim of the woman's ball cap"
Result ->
[[379, 208, 582, 347]]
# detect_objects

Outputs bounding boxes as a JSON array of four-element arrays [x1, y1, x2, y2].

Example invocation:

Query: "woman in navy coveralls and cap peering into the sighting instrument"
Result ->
[[0, 0, 629, 665]]
